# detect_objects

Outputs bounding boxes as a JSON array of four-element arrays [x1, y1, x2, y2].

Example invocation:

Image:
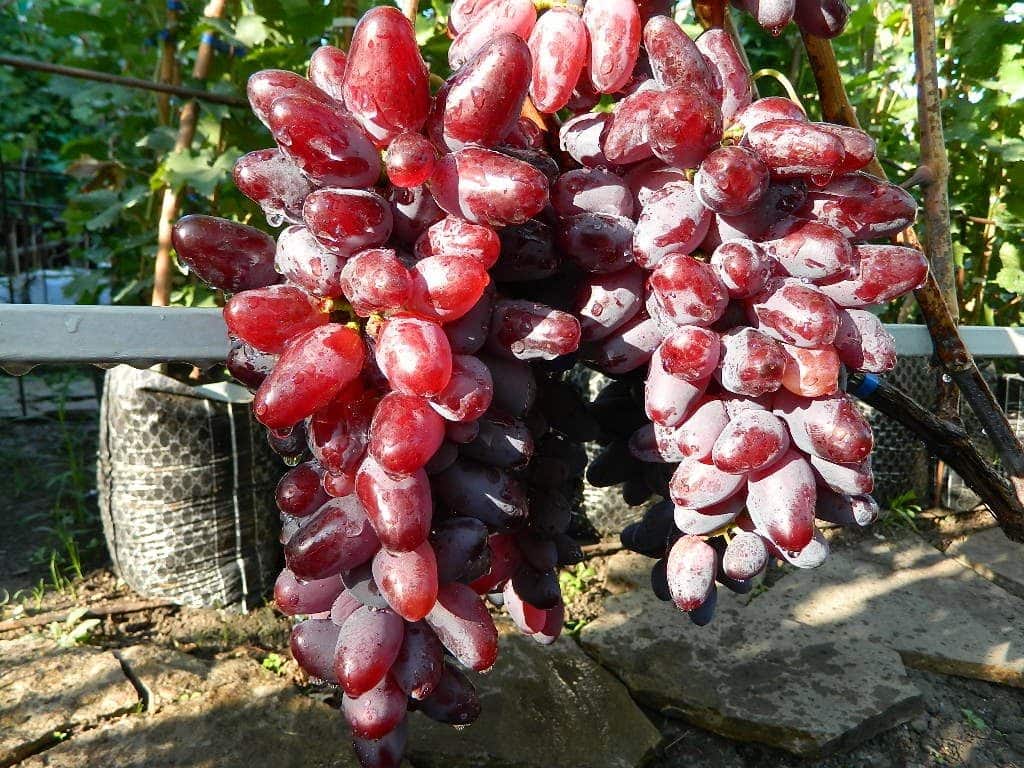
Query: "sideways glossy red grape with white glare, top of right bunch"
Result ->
[[743, 120, 846, 186]]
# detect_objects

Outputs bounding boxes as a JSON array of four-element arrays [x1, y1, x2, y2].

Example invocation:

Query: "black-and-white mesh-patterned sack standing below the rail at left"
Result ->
[[96, 366, 280, 610]]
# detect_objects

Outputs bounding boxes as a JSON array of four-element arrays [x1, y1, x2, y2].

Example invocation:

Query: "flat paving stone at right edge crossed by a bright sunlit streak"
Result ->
[[755, 536, 1024, 687]]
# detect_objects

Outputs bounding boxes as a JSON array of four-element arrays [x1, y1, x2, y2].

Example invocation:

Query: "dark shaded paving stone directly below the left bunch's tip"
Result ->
[[409, 631, 660, 768]]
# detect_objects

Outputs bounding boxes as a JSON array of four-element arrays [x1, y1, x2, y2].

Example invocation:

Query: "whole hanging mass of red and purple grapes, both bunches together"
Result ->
[[165, 0, 927, 768]]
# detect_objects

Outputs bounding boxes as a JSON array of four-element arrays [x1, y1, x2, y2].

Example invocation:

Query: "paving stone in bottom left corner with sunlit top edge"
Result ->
[[18, 658, 358, 768]]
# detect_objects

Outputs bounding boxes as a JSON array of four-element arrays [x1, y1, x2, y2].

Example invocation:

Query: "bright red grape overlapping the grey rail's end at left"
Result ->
[[224, 286, 329, 353]]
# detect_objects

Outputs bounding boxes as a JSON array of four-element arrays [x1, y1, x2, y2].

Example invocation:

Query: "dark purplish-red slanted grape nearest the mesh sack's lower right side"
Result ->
[[285, 497, 380, 580]]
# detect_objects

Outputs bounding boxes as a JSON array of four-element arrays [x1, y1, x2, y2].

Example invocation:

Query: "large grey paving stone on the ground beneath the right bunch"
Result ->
[[581, 553, 922, 756]]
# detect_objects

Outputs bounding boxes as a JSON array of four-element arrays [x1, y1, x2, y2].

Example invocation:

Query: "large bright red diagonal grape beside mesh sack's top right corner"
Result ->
[[253, 323, 364, 429]]
